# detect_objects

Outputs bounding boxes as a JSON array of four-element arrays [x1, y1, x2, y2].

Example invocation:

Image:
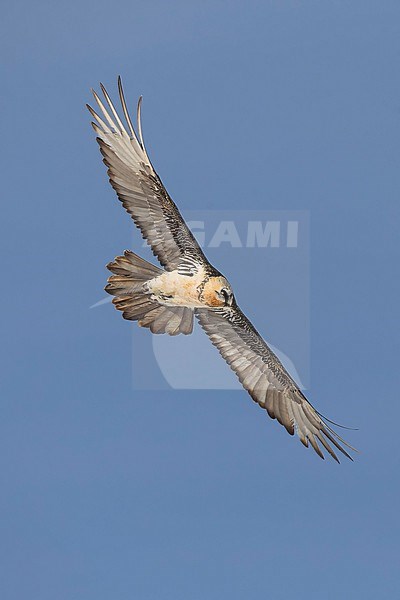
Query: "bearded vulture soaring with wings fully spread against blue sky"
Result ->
[[87, 78, 355, 462]]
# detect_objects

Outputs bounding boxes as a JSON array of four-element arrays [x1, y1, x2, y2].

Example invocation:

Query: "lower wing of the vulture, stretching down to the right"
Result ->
[[196, 306, 354, 462]]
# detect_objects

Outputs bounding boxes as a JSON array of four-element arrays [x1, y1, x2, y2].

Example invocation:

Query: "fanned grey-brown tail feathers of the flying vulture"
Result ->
[[105, 250, 193, 335]]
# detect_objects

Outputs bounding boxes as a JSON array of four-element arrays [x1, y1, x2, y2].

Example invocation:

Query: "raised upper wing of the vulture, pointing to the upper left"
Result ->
[[87, 78, 205, 271]]
